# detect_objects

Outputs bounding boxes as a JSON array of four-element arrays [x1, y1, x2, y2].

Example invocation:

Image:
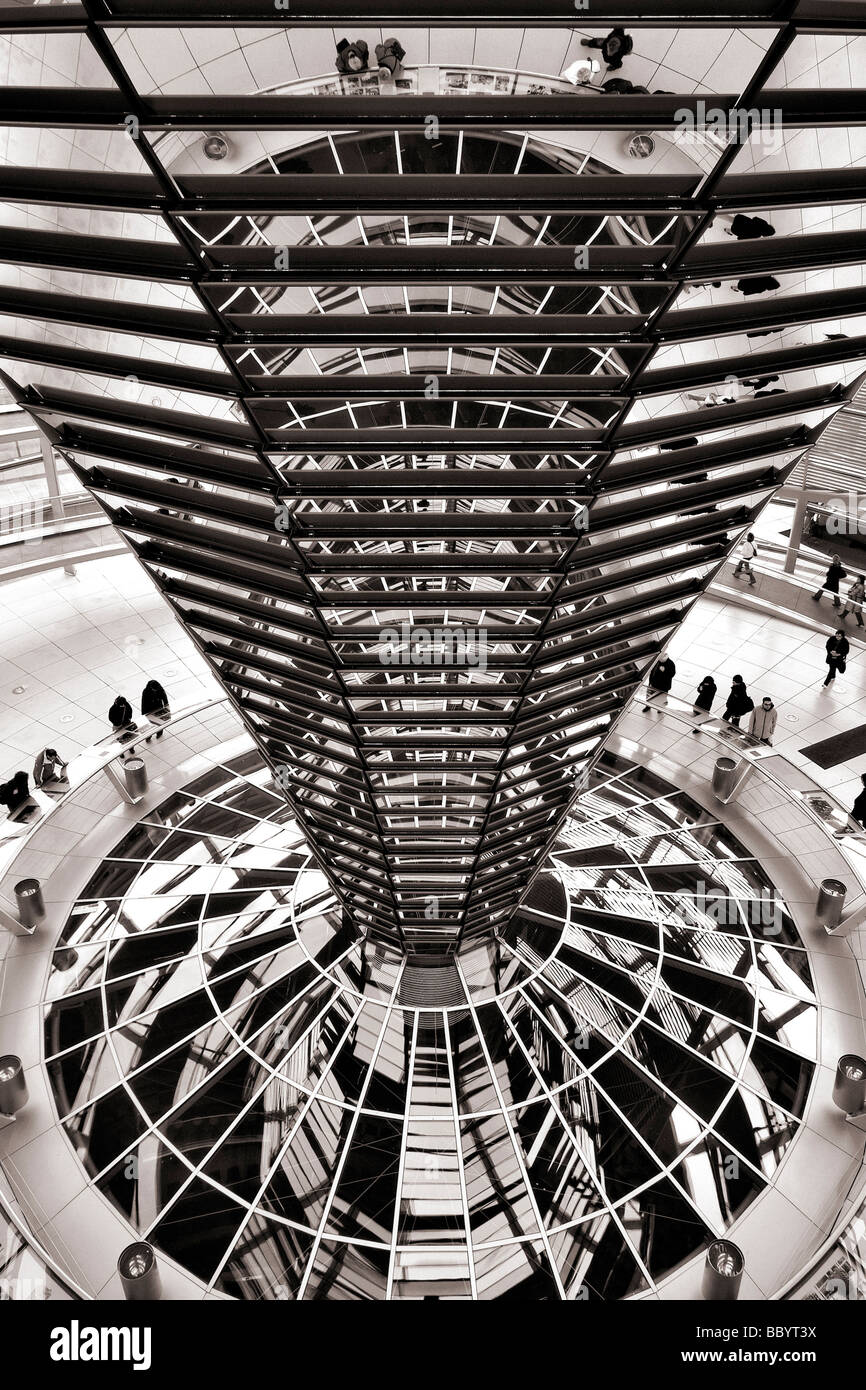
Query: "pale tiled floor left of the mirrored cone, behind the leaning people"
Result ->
[[0, 556, 218, 777]]
